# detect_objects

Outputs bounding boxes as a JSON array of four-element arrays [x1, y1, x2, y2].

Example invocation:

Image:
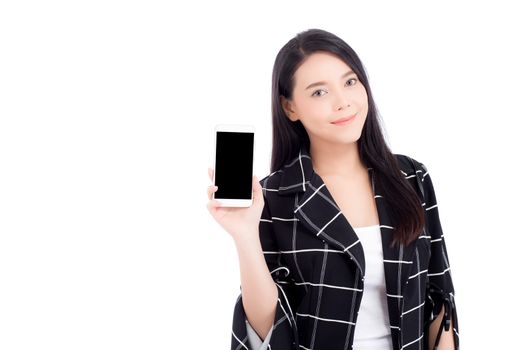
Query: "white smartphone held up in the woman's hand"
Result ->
[[213, 124, 255, 207]]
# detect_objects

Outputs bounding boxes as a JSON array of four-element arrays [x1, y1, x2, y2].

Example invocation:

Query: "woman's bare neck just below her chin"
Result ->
[[310, 141, 367, 178]]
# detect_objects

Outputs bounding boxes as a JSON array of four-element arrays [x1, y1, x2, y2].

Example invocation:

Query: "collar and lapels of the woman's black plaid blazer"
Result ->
[[278, 145, 417, 316]]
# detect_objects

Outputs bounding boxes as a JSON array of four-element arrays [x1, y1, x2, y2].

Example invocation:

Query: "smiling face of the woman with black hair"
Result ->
[[281, 52, 368, 144]]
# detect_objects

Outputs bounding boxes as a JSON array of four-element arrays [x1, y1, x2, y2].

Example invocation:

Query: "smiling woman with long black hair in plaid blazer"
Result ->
[[208, 29, 459, 350]]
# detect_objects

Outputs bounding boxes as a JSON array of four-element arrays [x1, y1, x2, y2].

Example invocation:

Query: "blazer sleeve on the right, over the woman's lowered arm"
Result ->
[[418, 164, 459, 349]]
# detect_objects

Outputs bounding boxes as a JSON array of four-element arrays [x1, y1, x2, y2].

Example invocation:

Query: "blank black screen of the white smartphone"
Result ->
[[215, 131, 254, 199]]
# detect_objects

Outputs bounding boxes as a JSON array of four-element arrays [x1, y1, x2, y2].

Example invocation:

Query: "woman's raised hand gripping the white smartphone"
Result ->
[[207, 168, 264, 242]]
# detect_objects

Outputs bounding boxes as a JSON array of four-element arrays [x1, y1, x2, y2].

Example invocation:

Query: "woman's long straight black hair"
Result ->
[[271, 29, 425, 245]]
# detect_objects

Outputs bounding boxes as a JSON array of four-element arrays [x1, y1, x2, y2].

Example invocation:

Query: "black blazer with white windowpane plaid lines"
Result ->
[[231, 146, 459, 350]]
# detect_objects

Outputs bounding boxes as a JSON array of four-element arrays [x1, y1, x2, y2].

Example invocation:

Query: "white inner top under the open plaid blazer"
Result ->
[[353, 225, 392, 350]]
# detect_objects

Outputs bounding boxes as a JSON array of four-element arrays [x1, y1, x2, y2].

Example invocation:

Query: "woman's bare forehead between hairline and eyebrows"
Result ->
[[294, 52, 351, 87]]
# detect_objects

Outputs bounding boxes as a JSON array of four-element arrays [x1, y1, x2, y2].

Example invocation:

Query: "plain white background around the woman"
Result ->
[[0, 0, 525, 350]]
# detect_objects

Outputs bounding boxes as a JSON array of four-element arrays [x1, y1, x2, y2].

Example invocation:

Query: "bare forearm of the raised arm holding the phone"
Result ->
[[235, 234, 278, 339]]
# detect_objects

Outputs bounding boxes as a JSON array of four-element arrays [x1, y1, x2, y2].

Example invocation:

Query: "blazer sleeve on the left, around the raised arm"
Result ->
[[231, 189, 299, 350]]
